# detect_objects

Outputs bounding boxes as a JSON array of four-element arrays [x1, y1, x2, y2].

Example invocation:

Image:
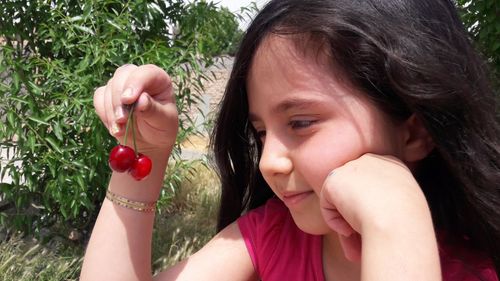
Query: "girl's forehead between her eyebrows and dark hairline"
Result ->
[[246, 33, 368, 109]]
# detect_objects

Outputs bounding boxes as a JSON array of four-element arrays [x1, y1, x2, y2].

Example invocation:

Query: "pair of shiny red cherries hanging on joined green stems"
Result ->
[[108, 104, 153, 181]]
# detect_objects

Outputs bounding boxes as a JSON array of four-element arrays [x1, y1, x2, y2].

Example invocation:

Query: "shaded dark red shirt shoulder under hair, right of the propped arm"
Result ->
[[438, 233, 498, 281]]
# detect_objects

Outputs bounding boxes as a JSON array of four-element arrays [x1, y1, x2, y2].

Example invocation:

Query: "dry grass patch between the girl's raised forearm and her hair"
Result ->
[[153, 162, 219, 271]]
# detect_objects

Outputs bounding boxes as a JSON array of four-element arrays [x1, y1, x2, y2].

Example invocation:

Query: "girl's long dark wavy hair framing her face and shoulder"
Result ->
[[212, 0, 500, 271]]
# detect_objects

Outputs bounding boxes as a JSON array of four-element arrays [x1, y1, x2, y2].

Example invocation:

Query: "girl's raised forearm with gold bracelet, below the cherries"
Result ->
[[80, 154, 167, 281]]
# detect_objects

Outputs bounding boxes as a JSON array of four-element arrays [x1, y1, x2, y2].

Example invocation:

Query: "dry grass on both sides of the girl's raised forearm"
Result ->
[[0, 159, 219, 281]]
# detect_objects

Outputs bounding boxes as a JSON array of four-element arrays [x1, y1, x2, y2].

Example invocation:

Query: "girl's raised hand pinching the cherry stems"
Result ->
[[94, 65, 178, 156]]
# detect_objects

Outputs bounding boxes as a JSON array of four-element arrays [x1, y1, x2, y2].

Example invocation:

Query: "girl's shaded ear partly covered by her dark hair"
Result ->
[[402, 114, 434, 163]]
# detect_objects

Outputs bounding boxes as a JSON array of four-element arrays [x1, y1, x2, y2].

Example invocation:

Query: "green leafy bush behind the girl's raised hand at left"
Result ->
[[0, 0, 238, 240]]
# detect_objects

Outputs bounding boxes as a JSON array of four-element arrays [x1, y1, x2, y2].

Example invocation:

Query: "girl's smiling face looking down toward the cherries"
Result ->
[[247, 35, 403, 234]]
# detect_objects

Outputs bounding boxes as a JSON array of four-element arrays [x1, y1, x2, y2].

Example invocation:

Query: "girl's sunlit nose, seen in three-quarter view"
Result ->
[[259, 133, 293, 176]]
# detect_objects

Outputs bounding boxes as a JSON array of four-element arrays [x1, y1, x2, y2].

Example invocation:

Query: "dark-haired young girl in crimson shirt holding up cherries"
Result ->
[[81, 0, 500, 281]]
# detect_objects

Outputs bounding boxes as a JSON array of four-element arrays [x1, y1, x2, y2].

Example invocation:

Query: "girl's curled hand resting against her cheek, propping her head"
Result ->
[[320, 154, 433, 261]]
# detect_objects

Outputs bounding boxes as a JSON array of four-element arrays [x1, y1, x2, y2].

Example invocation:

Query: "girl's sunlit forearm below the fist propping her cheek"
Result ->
[[362, 202, 441, 281]]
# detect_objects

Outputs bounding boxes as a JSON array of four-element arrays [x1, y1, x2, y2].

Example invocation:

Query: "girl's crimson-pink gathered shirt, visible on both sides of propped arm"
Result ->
[[238, 198, 498, 281]]
